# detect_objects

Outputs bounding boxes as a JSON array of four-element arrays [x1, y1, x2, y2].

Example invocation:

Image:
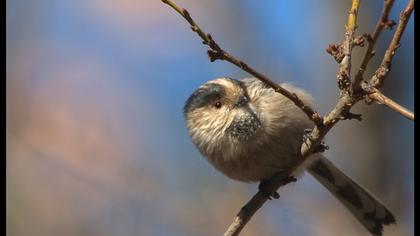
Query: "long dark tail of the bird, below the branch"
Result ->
[[307, 157, 395, 235]]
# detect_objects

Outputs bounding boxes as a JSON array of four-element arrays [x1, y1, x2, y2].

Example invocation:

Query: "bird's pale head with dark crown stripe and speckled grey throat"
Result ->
[[184, 78, 261, 157]]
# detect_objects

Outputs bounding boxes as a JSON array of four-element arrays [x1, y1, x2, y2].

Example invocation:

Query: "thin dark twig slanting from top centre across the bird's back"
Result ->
[[162, 0, 322, 125]]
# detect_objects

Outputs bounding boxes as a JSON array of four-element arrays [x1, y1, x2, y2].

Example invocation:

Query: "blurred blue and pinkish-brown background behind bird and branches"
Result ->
[[6, 0, 414, 236]]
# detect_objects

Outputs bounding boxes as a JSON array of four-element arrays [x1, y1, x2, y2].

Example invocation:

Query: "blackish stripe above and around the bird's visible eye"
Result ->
[[184, 83, 226, 113]]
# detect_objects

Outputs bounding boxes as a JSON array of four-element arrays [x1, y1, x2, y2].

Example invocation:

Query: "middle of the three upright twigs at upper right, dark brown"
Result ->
[[353, 0, 395, 90]]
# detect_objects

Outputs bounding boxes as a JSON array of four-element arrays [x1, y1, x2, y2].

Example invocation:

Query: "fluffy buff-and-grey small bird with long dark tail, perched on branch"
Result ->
[[184, 77, 395, 235]]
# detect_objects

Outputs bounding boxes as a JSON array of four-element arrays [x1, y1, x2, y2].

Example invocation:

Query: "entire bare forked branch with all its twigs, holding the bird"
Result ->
[[162, 0, 414, 236]]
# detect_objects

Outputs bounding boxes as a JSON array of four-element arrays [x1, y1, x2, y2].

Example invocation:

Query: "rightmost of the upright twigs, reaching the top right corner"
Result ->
[[369, 0, 414, 88]]
